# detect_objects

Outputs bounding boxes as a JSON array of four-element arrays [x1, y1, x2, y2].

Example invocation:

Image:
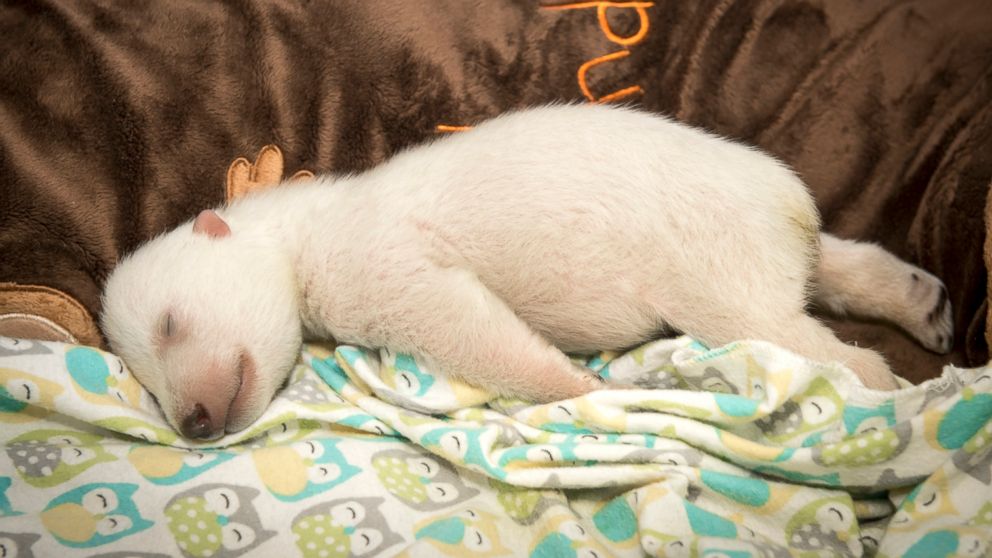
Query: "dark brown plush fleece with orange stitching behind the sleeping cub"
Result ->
[[0, 0, 992, 381]]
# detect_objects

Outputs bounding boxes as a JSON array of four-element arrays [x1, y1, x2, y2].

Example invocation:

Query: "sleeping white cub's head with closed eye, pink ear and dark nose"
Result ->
[[101, 211, 302, 439]]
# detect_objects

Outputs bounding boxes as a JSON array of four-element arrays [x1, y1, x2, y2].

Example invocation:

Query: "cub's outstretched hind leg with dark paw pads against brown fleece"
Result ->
[[814, 234, 954, 353]]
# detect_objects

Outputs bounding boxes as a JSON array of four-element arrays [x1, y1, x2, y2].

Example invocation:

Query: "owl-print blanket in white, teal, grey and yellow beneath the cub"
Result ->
[[0, 337, 992, 557]]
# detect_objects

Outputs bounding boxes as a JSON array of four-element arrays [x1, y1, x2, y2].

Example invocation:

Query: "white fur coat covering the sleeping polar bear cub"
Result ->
[[103, 105, 949, 435]]
